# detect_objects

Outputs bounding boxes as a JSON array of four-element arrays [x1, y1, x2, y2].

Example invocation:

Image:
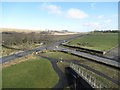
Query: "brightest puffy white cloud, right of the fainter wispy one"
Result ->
[[64, 8, 88, 19]]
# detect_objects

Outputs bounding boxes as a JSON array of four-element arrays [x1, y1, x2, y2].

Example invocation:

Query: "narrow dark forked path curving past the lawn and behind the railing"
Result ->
[[37, 56, 120, 90]]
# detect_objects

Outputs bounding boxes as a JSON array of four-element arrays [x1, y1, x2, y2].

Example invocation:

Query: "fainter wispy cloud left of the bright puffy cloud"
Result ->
[[42, 3, 62, 15]]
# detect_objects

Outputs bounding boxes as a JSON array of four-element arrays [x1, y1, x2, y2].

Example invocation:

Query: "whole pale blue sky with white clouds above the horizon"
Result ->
[[0, 2, 118, 32]]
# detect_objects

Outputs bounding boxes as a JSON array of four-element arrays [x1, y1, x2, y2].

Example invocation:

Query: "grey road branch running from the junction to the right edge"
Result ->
[[48, 46, 120, 68]]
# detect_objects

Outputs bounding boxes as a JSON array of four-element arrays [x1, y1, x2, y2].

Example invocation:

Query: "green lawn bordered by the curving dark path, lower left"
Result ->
[[2, 58, 59, 88]]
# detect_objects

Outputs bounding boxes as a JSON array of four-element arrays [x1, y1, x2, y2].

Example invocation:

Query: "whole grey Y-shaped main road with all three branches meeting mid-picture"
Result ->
[[0, 35, 120, 68]]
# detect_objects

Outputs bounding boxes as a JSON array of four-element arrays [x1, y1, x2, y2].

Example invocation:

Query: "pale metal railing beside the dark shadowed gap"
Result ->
[[70, 63, 108, 88]]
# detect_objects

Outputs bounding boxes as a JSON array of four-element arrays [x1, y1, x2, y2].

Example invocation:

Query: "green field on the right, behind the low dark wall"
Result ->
[[68, 33, 118, 51]]
